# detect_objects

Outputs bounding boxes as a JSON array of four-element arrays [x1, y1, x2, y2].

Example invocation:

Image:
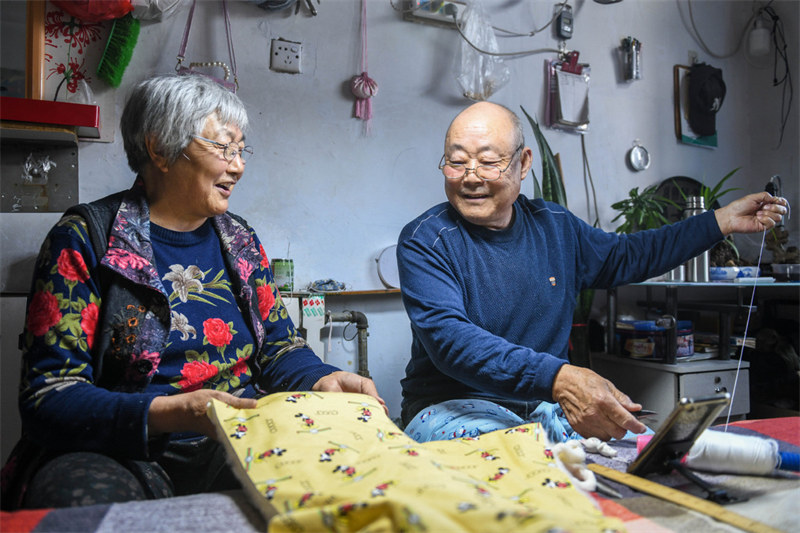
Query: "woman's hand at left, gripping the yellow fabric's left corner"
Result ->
[[147, 389, 256, 439]]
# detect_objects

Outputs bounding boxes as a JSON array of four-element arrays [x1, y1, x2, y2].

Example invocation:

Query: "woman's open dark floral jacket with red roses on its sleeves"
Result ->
[[19, 180, 338, 460]]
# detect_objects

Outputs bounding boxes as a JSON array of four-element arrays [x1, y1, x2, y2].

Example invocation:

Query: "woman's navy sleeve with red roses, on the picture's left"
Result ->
[[19, 216, 156, 459]]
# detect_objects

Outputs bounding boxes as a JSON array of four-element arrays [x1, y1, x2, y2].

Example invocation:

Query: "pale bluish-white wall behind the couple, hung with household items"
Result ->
[[2, 0, 800, 460]]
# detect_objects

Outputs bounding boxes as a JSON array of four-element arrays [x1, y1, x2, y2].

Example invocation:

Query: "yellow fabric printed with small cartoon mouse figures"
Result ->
[[209, 392, 624, 533]]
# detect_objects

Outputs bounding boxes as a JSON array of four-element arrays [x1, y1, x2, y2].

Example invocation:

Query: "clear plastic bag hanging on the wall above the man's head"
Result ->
[[455, 0, 511, 101]]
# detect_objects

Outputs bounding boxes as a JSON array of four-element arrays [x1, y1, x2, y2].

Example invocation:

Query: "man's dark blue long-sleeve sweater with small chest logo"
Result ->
[[397, 195, 723, 421]]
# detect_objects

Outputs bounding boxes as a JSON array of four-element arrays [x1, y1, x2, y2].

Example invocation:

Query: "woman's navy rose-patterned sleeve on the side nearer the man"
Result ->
[[250, 229, 339, 392]]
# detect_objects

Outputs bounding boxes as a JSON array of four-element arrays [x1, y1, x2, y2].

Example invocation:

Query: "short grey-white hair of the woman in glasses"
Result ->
[[120, 74, 248, 173]]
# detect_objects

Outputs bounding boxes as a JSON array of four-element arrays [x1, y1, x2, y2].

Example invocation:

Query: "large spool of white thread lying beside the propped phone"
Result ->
[[684, 430, 779, 475]]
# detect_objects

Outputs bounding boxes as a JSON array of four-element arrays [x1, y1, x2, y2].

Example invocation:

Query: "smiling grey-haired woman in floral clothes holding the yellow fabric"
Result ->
[[3, 75, 382, 508]]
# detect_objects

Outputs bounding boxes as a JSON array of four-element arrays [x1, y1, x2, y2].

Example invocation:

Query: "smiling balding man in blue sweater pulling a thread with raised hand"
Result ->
[[397, 102, 786, 441]]
